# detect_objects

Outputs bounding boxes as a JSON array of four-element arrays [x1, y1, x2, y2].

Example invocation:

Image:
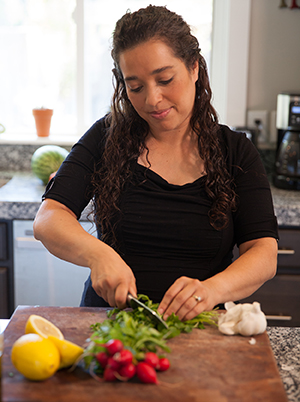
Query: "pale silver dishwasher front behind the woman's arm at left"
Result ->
[[13, 220, 96, 308]]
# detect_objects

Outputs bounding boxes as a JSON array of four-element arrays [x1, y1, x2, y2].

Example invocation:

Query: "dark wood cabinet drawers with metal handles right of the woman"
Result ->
[[241, 227, 300, 327]]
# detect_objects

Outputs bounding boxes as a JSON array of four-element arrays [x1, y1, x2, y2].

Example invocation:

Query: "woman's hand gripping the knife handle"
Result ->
[[90, 243, 137, 309]]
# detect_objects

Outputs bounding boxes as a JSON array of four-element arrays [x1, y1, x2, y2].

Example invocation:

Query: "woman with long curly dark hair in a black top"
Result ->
[[34, 6, 277, 320]]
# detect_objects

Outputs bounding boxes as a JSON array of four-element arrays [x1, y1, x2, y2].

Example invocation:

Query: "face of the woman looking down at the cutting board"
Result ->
[[120, 40, 198, 135]]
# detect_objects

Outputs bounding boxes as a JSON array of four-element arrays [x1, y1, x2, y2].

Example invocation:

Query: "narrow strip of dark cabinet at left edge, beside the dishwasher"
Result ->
[[0, 219, 14, 318]]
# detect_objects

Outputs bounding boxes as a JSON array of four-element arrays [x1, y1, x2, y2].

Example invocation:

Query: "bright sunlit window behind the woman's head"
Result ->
[[0, 0, 213, 138]]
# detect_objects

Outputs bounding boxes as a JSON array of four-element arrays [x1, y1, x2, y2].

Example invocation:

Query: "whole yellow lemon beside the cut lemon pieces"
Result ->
[[11, 334, 60, 381]]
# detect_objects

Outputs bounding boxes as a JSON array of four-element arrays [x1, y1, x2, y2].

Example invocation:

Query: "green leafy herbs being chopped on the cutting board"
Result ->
[[84, 295, 218, 366]]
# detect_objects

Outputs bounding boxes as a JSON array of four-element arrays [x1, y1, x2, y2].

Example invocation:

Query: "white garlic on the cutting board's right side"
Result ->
[[218, 302, 267, 336]]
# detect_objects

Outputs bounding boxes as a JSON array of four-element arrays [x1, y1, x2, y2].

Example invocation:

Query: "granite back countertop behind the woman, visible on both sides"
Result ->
[[0, 172, 300, 227]]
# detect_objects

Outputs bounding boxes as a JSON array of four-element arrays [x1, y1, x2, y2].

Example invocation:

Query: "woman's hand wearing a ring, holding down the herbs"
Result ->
[[158, 276, 215, 321]]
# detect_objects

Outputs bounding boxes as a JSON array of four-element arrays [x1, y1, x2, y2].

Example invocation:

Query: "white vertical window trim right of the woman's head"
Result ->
[[210, 0, 251, 126]]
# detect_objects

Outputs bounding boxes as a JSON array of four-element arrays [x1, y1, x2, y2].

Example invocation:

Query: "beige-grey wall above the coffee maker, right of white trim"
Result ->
[[247, 0, 300, 112]]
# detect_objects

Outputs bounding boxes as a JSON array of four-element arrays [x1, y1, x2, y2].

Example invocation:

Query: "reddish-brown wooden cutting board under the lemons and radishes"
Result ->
[[2, 306, 287, 402]]
